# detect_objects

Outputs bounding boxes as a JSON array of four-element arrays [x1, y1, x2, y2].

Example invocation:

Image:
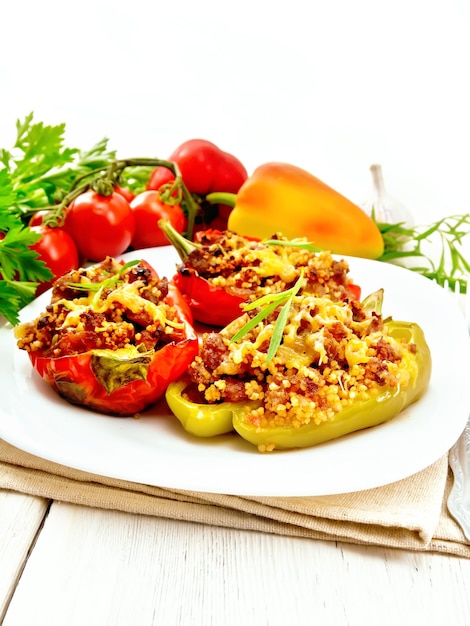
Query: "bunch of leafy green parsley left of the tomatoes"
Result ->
[[0, 113, 115, 324]]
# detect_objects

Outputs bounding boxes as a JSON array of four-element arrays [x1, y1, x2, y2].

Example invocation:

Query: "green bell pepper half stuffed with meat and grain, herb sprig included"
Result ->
[[166, 290, 432, 452]]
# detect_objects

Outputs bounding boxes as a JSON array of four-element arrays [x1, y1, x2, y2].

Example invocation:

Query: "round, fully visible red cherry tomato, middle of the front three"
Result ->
[[64, 190, 135, 261]]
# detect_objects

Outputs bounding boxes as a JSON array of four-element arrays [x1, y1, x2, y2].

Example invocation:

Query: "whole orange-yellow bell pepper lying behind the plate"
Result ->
[[207, 163, 384, 259]]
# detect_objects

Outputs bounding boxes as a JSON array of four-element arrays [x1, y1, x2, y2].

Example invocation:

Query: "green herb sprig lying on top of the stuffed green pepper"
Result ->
[[230, 271, 304, 365]]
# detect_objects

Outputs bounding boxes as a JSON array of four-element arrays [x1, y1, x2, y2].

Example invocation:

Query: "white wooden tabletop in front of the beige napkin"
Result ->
[[0, 491, 470, 626]]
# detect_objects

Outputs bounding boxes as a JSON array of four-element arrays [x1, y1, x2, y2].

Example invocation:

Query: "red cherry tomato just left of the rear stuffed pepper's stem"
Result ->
[[131, 191, 186, 249]]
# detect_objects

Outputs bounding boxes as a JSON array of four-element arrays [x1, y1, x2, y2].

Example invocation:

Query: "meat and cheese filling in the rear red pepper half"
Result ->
[[178, 231, 360, 300]]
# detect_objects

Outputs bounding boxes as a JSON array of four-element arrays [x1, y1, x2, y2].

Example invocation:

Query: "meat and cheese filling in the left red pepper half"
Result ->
[[16, 258, 184, 358]]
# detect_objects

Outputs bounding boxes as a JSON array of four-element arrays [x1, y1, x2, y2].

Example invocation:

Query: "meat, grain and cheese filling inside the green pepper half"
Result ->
[[188, 294, 415, 428]]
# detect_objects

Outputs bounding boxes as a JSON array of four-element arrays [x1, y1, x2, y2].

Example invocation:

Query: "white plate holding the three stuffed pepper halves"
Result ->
[[0, 247, 470, 496]]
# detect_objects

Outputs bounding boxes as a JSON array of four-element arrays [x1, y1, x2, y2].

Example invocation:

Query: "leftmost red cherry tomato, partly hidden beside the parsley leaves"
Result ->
[[31, 226, 79, 295]]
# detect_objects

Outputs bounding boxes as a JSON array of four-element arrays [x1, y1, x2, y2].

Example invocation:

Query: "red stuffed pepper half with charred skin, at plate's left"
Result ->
[[15, 258, 198, 416]]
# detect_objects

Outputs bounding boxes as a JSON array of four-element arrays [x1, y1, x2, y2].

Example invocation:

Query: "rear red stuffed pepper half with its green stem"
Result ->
[[160, 221, 360, 326]]
